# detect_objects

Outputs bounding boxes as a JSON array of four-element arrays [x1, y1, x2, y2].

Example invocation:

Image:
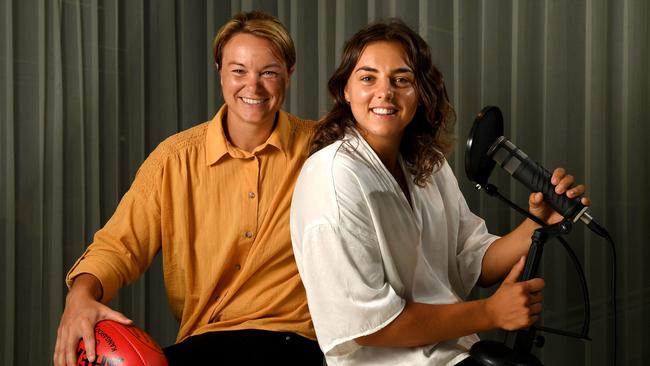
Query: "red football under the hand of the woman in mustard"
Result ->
[[77, 320, 167, 366]]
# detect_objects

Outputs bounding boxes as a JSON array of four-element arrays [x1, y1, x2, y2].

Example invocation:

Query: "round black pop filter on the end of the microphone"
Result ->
[[465, 106, 503, 186]]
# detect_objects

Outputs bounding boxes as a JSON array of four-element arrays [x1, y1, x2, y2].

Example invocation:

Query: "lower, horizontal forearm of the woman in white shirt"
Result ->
[[356, 300, 495, 347]]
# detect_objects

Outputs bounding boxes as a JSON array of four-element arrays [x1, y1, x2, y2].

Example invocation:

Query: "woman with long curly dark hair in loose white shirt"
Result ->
[[291, 20, 589, 365]]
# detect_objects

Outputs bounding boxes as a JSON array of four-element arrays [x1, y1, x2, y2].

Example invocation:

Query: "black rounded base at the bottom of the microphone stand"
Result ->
[[469, 341, 543, 366]]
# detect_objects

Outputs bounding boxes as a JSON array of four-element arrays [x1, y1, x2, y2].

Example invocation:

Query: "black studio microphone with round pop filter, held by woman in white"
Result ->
[[465, 106, 606, 237]]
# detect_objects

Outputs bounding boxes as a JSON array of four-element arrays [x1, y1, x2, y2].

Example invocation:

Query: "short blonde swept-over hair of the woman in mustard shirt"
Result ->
[[212, 10, 296, 71]]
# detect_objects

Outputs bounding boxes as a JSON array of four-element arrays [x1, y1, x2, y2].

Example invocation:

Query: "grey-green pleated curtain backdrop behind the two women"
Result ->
[[0, 0, 650, 365]]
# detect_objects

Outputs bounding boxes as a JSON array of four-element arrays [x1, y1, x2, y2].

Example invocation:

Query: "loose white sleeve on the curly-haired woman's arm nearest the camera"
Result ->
[[296, 224, 405, 356]]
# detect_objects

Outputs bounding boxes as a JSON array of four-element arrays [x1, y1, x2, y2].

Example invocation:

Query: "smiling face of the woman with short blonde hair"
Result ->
[[219, 33, 290, 129]]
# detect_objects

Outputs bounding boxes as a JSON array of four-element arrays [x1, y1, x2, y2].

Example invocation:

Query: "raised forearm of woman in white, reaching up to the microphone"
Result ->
[[478, 219, 539, 286]]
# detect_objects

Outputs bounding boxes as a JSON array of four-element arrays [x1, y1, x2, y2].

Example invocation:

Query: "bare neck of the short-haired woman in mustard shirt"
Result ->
[[223, 111, 275, 152]]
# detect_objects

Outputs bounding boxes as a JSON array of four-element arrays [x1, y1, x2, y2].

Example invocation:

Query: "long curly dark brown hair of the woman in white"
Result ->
[[310, 19, 456, 186]]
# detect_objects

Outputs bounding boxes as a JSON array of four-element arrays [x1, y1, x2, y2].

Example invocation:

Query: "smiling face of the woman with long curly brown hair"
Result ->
[[345, 41, 418, 154]]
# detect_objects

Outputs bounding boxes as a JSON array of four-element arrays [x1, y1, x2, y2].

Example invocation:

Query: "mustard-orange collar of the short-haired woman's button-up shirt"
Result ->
[[205, 105, 291, 165]]
